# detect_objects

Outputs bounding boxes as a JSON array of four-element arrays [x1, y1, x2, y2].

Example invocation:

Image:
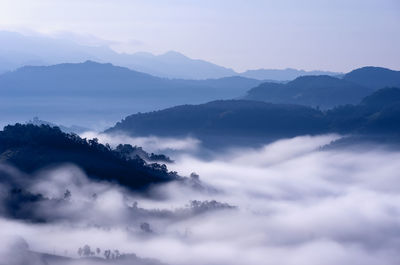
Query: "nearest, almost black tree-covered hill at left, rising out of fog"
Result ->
[[0, 124, 179, 190]]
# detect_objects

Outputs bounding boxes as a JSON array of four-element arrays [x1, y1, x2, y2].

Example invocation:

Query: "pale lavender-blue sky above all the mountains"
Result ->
[[0, 0, 400, 72]]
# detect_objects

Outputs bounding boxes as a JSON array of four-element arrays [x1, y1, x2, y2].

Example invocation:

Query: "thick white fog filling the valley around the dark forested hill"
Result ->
[[0, 133, 400, 265]]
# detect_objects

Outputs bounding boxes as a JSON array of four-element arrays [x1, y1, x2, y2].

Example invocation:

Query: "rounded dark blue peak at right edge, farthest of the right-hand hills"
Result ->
[[343, 66, 400, 90]]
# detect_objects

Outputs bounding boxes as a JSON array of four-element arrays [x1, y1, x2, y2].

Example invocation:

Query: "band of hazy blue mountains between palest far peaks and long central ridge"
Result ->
[[0, 57, 400, 129]]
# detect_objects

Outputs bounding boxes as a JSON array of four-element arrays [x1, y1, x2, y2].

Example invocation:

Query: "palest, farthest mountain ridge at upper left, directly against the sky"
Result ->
[[0, 31, 236, 79]]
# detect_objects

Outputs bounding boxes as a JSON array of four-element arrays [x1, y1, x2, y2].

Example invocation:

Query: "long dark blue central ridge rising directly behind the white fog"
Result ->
[[106, 100, 328, 147]]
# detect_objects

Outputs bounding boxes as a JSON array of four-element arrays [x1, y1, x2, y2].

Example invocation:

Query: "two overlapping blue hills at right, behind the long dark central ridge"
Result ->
[[245, 67, 400, 108]]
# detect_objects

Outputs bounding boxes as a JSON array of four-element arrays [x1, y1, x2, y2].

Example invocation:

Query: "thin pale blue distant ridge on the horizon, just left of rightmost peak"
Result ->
[[240, 68, 342, 81]]
